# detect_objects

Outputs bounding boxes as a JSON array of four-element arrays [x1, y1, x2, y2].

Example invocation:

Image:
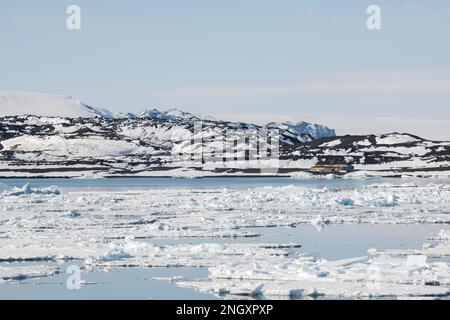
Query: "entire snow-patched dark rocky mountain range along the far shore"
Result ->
[[0, 93, 450, 177]]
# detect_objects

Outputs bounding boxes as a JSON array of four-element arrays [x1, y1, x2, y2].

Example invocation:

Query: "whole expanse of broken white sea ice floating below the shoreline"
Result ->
[[0, 180, 450, 298]]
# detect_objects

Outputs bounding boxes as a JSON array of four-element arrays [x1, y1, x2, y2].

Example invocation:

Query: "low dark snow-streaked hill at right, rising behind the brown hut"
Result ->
[[282, 133, 450, 176]]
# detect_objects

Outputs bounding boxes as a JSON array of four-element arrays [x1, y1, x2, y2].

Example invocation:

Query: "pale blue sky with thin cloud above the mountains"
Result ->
[[0, 0, 450, 140]]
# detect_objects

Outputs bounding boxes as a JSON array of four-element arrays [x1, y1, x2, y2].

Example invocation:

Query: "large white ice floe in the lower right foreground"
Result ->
[[177, 232, 450, 298]]
